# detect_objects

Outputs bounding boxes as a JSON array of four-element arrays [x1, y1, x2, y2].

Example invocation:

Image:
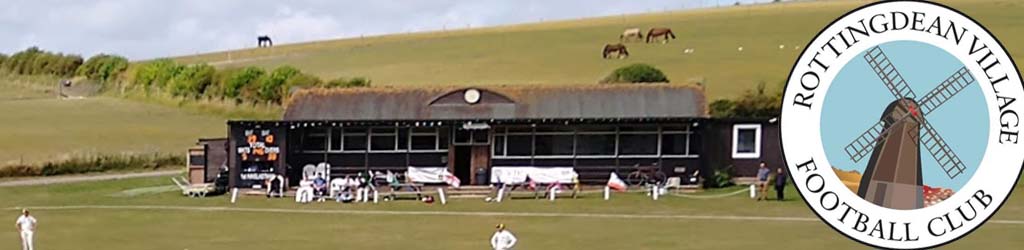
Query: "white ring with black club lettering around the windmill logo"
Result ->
[[780, 1, 1024, 249]]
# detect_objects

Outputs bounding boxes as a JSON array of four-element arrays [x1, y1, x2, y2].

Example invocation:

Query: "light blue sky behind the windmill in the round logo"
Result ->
[[821, 41, 989, 191]]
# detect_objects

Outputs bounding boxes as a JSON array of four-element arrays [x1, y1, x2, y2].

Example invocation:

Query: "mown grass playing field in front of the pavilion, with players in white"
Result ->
[[0, 177, 1024, 250]]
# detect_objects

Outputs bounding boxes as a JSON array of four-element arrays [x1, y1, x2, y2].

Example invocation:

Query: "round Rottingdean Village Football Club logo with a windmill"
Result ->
[[780, 1, 1024, 249]]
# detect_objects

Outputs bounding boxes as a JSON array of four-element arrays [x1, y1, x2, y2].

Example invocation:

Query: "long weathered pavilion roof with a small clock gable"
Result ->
[[284, 84, 708, 121]]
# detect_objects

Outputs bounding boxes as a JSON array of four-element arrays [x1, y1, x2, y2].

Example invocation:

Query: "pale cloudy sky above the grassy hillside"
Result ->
[[0, 0, 764, 59]]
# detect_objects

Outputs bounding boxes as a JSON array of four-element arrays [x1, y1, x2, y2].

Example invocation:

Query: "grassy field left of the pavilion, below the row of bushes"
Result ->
[[0, 80, 226, 166]]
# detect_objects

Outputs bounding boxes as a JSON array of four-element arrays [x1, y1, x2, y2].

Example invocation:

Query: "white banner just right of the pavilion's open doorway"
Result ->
[[490, 167, 578, 184]]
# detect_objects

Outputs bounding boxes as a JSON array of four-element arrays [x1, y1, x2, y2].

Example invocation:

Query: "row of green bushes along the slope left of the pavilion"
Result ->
[[0, 47, 371, 105]]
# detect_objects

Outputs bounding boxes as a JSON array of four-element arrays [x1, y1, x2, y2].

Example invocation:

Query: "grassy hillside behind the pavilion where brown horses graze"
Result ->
[[175, 0, 1024, 98]]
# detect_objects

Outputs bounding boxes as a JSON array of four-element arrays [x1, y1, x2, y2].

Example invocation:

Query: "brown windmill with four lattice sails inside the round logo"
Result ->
[[845, 47, 975, 209]]
